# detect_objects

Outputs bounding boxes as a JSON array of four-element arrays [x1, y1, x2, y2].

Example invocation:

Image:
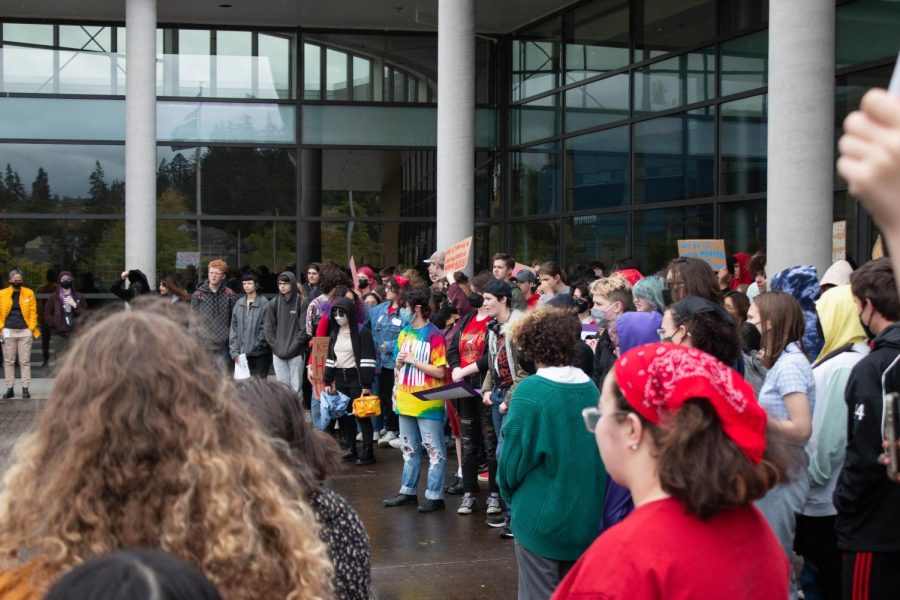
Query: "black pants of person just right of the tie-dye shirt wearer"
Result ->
[[456, 398, 500, 494]]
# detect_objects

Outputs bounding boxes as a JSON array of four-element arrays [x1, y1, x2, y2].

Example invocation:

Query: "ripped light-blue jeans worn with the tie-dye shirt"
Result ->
[[400, 415, 447, 500]]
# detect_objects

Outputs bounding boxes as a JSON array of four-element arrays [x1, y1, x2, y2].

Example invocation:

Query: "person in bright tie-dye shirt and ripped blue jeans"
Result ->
[[384, 288, 447, 513]]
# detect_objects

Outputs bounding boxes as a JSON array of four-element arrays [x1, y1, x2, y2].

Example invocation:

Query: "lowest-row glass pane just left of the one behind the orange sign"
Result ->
[[563, 213, 628, 266]]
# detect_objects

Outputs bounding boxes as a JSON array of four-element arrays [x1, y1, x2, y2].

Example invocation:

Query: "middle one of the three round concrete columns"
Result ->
[[438, 0, 475, 271]]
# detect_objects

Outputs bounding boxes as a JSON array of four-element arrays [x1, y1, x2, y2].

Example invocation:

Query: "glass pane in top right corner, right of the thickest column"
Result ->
[[835, 0, 900, 69]]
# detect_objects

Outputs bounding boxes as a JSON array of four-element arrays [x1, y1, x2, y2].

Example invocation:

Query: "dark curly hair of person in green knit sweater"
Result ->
[[511, 307, 581, 367]]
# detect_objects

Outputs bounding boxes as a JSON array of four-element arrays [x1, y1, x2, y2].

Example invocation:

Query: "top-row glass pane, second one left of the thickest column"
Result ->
[[634, 0, 716, 62]]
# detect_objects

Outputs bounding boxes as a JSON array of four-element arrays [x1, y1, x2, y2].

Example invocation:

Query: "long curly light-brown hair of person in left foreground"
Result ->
[[0, 311, 332, 600]]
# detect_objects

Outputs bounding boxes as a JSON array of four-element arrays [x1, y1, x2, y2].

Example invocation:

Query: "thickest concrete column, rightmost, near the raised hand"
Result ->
[[766, 0, 835, 277]]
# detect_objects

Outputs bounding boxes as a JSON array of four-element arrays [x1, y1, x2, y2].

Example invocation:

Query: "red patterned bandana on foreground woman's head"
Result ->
[[615, 343, 766, 463]]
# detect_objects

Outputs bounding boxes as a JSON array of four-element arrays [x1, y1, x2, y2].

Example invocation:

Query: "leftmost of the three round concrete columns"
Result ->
[[122, 0, 156, 287]]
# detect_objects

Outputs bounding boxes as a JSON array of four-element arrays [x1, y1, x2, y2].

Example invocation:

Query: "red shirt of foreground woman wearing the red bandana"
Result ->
[[552, 498, 790, 600]]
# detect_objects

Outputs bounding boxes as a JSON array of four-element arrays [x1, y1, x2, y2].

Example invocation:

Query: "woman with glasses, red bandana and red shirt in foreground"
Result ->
[[553, 343, 790, 600]]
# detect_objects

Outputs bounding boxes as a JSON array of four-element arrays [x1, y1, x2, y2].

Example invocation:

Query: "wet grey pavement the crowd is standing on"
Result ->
[[0, 378, 516, 600]]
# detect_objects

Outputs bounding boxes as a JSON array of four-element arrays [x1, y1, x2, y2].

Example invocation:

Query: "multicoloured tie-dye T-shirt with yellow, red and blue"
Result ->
[[395, 323, 447, 420]]
